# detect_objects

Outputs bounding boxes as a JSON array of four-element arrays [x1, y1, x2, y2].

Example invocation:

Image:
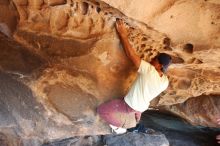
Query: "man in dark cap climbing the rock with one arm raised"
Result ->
[[97, 19, 171, 134]]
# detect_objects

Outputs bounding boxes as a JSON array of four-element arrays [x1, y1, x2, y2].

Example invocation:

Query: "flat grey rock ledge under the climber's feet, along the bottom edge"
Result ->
[[42, 132, 169, 146]]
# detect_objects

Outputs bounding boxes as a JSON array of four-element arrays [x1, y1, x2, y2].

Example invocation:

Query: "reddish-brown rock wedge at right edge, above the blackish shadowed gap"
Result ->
[[163, 95, 220, 127]]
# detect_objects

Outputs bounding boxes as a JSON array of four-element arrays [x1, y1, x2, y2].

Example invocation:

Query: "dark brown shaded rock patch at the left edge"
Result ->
[[0, 33, 46, 75]]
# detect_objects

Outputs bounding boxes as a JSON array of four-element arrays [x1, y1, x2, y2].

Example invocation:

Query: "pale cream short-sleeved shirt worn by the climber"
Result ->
[[125, 60, 169, 112]]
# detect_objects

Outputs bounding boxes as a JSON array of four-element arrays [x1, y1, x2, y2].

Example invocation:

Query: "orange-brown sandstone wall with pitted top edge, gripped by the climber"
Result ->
[[11, 1, 169, 129]]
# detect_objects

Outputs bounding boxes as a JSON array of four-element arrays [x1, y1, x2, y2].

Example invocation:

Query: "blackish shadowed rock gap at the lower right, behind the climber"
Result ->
[[141, 110, 220, 146]]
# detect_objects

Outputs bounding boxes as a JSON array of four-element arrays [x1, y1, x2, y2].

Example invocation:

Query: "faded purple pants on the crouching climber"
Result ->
[[97, 99, 141, 128]]
